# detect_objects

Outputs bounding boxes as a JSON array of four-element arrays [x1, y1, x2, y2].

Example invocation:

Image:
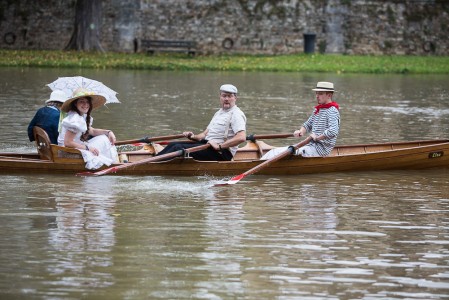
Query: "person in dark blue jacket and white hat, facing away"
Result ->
[[28, 91, 68, 144]]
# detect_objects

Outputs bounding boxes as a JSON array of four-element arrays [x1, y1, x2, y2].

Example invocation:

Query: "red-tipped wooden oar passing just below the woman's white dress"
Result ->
[[76, 144, 210, 176]]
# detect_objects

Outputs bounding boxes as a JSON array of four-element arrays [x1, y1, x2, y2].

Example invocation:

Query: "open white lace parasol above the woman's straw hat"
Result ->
[[47, 76, 120, 104]]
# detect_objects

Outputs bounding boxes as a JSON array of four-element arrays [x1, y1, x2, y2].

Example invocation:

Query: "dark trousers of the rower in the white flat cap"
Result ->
[[156, 141, 232, 161]]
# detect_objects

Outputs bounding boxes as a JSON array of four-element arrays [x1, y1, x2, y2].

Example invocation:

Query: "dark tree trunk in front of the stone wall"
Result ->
[[64, 0, 104, 52]]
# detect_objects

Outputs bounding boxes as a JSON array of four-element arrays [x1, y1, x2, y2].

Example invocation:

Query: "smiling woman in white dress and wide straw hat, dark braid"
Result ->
[[58, 88, 118, 170]]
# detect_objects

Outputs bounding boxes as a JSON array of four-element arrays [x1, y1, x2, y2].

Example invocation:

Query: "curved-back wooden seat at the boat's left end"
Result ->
[[33, 126, 82, 162]]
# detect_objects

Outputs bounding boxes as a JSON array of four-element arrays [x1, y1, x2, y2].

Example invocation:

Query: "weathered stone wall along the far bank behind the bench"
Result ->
[[0, 0, 449, 55]]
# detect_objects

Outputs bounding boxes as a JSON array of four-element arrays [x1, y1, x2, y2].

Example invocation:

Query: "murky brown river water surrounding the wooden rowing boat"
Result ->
[[0, 68, 449, 299]]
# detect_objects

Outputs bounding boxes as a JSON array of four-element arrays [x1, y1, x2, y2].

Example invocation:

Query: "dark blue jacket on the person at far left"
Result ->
[[28, 106, 59, 144]]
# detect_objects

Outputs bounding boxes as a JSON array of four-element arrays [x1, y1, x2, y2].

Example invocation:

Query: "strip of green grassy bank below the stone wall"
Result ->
[[0, 50, 449, 74]]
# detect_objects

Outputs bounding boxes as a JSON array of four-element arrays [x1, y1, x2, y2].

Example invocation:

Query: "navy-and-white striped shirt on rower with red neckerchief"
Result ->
[[302, 107, 340, 156]]
